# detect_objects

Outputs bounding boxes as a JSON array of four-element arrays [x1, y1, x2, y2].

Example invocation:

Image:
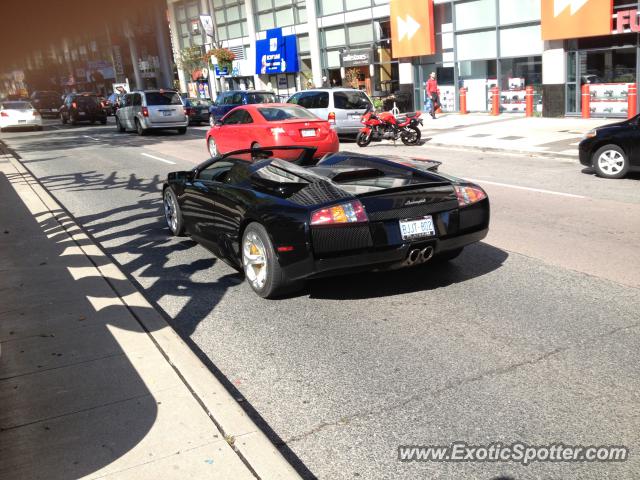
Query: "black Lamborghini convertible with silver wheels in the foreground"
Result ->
[[162, 146, 489, 298]]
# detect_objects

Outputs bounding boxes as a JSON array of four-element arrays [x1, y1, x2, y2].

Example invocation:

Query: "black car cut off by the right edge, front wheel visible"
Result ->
[[578, 115, 640, 178]]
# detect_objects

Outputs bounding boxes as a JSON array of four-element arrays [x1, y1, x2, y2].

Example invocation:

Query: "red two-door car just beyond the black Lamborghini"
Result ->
[[207, 103, 340, 157]]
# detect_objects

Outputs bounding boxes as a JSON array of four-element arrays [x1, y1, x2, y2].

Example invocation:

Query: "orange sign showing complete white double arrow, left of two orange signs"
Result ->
[[390, 0, 436, 58]]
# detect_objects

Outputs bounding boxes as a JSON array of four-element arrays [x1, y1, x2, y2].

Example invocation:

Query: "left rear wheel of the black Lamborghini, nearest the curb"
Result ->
[[241, 222, 295, 298]]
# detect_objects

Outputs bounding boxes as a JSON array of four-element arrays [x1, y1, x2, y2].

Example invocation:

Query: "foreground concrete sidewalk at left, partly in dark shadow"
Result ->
[[0, 144, 300, 480]]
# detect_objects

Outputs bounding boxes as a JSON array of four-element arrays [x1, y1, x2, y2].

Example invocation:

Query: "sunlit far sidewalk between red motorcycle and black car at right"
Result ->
[[422, 113, 622, 159]]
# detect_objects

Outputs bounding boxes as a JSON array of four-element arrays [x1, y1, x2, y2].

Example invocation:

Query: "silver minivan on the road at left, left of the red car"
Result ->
[[116, 90, 189, 135]]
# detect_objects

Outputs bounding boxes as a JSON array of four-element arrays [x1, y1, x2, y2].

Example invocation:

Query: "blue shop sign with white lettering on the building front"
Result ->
[[256, 28, 299, 75]]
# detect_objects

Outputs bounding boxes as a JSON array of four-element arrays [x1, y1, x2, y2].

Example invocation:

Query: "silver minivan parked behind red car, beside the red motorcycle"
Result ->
[[287, 88, 373, 135]]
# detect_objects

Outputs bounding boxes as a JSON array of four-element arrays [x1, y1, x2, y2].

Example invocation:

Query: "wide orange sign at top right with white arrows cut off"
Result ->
[[540, 0, 613, 40]]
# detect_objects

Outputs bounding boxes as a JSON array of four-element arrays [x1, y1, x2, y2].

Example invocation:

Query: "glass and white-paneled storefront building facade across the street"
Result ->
[[168, 0, 640, 116]]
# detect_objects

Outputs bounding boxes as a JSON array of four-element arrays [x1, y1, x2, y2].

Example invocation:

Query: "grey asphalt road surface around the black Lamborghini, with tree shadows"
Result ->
[[0, 118, 640, 479]]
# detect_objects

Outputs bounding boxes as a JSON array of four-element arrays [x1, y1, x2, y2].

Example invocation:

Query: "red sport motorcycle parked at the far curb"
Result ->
[[356, 108, 422, 147]]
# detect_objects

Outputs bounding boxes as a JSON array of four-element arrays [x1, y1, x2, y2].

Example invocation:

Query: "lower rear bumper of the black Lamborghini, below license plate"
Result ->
[[283, 227, 489, 280]]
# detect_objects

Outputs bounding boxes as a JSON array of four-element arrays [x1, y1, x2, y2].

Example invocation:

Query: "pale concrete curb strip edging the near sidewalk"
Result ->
[[0, 142, 302, 480]]
